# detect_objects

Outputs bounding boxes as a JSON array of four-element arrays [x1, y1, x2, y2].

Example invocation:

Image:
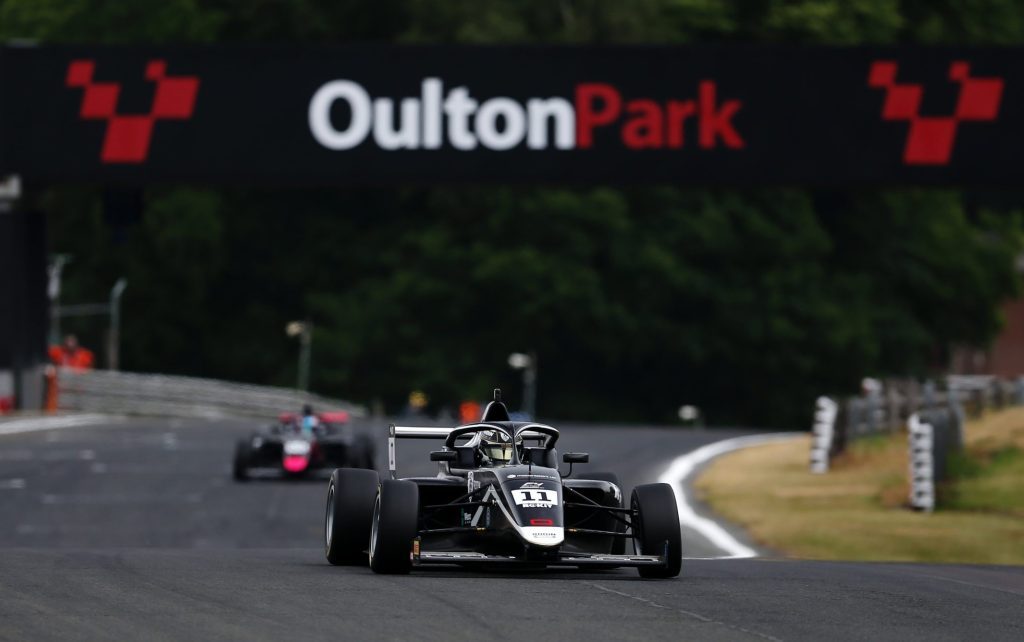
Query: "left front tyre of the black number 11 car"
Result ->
[[370, 479, 420, 573]]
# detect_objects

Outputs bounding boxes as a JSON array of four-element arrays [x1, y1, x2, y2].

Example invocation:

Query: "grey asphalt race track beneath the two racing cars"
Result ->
[[0, 420, 1024, 641]]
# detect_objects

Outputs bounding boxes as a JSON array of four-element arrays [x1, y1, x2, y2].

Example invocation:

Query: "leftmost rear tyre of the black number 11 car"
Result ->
[[324, 468, 380, 565]]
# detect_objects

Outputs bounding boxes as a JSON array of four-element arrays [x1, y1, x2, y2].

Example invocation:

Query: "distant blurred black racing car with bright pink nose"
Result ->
[[231, 412, 374, 481]]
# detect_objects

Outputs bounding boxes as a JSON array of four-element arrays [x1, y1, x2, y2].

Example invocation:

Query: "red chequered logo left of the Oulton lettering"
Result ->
[[67, 60, 199, 163]]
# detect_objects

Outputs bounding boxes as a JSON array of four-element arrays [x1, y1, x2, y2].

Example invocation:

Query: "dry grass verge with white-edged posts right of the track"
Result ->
[[695, 409, 1024, 564]]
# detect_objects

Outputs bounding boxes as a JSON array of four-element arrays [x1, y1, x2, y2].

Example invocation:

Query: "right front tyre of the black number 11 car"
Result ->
[[630, 483, 683, 577]]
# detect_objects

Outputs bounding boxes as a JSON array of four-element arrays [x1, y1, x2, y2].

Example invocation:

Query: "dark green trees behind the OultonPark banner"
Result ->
[[14, 0, 1024, 426]]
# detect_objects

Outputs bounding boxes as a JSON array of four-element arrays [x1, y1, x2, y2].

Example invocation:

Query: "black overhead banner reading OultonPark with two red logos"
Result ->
[[0, 45, 1024, 185]]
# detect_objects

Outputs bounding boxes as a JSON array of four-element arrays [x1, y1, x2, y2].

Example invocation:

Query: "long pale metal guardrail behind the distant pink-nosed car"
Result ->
[[57, 369, 367, 418]]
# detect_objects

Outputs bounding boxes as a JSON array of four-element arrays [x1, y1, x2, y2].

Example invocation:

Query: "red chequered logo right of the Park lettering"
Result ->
[[867, 60, 1004, 165]]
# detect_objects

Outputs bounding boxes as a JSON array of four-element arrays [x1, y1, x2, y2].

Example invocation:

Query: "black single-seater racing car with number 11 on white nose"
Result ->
[[325, 390, 682, 577]]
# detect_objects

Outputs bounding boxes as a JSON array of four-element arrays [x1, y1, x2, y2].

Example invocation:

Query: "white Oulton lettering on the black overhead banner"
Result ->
[[308, 78, 575, 151]]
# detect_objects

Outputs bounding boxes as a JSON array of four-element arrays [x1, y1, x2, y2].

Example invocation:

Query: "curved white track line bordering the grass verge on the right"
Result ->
[[657, 432, 807, 559]]
